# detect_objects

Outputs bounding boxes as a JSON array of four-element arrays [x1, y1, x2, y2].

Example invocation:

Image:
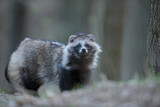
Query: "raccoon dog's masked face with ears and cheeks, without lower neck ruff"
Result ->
[[68, 33, 100, 59]]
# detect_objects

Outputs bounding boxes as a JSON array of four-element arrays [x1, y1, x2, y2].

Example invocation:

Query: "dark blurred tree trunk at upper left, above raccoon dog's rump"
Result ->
[[9, 0, 26, 53]]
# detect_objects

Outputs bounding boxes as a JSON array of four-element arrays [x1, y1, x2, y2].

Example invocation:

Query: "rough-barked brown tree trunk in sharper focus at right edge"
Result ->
[[147, 0, 160, 74]]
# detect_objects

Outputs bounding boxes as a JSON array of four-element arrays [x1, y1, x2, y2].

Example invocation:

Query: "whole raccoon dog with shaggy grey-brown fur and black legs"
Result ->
[[5, 33, 101, 92]]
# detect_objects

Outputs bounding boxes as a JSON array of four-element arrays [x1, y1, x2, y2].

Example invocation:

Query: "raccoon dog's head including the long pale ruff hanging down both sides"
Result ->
[[62, 33, 101, 69]]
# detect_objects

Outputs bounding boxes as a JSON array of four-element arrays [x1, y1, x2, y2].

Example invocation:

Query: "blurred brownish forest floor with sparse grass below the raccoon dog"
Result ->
[[0, 80, 160, 107]]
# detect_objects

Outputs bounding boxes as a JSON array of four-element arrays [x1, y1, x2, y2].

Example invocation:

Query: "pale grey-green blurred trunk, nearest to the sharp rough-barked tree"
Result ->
[[121, 0, 148, 80]]
